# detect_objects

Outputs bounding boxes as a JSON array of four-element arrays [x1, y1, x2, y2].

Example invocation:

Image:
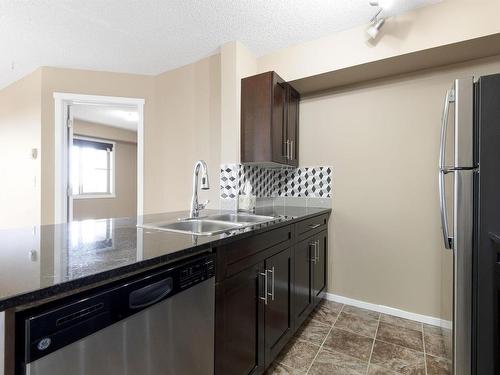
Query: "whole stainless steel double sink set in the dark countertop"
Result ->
[[139, 213, 278, 236]]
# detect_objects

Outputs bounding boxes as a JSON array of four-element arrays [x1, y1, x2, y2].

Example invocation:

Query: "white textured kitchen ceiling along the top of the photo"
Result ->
[[0, 0, 439, 87]]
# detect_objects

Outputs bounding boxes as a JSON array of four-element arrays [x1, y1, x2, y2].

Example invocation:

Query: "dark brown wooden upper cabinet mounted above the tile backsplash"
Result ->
[[241, 72, 300, 166]]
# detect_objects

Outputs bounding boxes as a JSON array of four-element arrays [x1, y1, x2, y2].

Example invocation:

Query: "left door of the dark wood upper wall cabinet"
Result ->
[[271, 79, 288, 164]]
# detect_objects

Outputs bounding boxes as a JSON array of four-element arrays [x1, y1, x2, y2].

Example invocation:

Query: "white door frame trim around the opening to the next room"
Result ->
[[53, 92, 145, 224]]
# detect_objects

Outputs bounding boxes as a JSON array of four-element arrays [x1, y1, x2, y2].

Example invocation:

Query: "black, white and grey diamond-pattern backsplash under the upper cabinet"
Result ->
[[220, 164, 332, 199]]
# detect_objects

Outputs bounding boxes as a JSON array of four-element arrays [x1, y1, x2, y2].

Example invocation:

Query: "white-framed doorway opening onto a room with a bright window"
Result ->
[[54, 93, 144, 223]]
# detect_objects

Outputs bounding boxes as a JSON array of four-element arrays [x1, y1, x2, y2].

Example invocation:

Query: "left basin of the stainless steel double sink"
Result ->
[[140, 218, 242, 236]]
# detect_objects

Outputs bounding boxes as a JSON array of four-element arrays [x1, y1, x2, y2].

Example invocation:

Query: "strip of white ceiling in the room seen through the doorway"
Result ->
[[71, 104, 138, 131]]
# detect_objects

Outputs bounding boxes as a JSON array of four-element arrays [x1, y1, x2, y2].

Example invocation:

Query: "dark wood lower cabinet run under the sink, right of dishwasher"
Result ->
[[215, 217, 328, 375]]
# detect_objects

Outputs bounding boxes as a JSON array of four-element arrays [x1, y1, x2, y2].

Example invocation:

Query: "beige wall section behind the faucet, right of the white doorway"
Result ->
[[149, 55, 221, 213]]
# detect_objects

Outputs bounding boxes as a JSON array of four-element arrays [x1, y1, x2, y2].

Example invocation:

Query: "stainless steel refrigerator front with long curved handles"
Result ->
[[438, 77, 475, 375]]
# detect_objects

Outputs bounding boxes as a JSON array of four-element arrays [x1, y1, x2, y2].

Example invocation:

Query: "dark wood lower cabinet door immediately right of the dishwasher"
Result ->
[[215, 263, 264, 375]]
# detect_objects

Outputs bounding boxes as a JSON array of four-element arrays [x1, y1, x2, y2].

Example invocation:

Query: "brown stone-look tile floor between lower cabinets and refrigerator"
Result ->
[[267, 301, 451, 375]]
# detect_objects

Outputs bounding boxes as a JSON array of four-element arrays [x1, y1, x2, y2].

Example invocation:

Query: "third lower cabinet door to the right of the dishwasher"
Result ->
[[293, 239, 313, 327]]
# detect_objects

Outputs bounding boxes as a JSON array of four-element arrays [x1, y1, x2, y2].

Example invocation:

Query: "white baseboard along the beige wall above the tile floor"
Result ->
[[325, 293, 452, 329]]
